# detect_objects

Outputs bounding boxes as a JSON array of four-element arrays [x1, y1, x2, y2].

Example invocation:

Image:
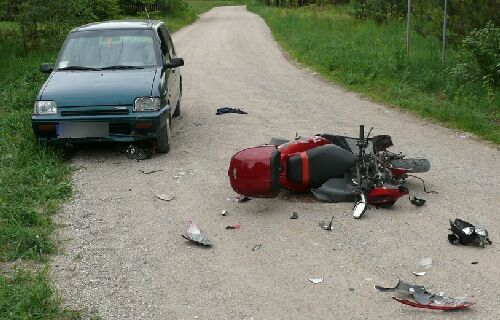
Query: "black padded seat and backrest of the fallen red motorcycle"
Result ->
[[286, 144, 356, 188]]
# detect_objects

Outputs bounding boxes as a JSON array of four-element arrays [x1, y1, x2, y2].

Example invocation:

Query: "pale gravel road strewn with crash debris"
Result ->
[[51, 6, 500, 319]]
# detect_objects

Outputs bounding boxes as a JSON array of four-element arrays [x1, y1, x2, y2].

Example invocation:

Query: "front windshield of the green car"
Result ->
[[57, 30, 159, 70]]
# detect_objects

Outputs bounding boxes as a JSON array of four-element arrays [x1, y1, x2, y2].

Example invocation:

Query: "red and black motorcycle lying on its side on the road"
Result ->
[[228, 125, 430, 218]]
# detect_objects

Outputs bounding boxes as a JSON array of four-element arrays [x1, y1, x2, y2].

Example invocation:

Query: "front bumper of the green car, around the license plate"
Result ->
[[31, 106, 170, 144]]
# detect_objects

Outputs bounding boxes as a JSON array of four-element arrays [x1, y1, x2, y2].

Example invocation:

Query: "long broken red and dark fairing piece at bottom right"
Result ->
[[375, 280, 474, 310]]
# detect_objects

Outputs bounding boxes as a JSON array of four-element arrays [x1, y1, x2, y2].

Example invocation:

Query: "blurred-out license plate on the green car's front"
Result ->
[[57, 121, 109, 138]]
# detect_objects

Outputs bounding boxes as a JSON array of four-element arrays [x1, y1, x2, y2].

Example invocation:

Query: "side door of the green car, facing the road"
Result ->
[[157, 25, 178, 113]]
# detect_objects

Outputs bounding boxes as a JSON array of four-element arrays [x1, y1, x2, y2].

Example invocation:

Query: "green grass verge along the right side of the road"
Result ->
[[249, 4, 500, 144]]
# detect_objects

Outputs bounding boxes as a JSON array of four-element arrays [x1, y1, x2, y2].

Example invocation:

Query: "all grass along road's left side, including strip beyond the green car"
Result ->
[[0, 0, 239, 320]]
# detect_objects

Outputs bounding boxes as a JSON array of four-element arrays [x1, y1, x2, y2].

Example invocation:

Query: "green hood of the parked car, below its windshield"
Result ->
[[38, 68, 157, 108]]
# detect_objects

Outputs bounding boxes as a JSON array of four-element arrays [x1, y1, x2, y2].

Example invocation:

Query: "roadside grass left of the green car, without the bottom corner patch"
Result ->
[[0, 43, 71, 261]]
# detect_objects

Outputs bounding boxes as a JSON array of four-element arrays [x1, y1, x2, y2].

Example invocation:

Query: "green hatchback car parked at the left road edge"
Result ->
[[31, 20, 184, 153]]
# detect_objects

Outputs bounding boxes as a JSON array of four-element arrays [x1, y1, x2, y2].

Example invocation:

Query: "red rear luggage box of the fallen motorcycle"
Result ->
[[228, 146, 281, 198]]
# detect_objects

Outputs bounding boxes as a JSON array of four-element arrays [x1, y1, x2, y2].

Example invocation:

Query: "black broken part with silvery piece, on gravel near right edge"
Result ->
[[448, 219, 492, 248]]
